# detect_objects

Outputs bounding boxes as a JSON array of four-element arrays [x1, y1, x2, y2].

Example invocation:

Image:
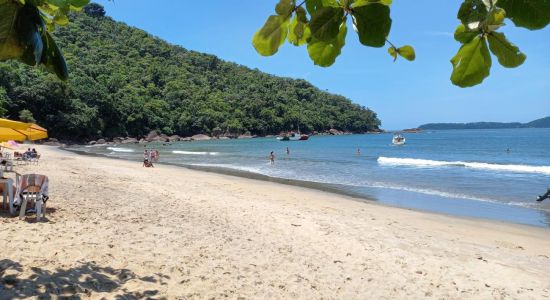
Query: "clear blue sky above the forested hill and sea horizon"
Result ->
[[97, 0, 550, 129]]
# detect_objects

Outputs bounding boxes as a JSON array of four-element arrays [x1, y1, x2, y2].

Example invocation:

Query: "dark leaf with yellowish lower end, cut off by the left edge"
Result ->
[[0, 0, 23, 61]]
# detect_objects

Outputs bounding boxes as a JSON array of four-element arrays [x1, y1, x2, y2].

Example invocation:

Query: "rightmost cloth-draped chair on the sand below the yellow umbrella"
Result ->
[[14, 174, 49, 221]]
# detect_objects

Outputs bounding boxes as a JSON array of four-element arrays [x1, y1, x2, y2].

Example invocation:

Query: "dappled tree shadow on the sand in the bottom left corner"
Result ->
[[0, 259, 166, 300]]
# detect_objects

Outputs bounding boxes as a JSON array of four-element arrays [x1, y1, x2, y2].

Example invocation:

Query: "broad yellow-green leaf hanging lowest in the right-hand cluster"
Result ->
[[451, 36, 491, 87]]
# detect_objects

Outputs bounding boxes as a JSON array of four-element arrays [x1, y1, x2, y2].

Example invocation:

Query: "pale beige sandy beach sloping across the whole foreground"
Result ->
[[0, 146, 550, 299]]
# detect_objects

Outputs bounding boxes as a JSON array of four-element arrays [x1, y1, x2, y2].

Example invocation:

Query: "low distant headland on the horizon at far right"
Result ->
[[418, 117, 550, 130]]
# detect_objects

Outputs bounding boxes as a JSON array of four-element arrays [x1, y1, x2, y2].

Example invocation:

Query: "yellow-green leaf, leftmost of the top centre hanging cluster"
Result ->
[[252, 15, 288, 56]]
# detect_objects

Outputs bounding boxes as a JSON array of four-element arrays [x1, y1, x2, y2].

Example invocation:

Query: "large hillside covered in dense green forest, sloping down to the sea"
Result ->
[[0, 4, 380, 140]]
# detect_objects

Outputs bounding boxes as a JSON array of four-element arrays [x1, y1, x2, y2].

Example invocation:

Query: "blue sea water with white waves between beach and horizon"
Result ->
[[70, 129, 550, 227]]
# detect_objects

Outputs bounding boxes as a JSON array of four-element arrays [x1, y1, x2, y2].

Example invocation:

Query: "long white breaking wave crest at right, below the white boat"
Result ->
[[378, 156, 550, 175]]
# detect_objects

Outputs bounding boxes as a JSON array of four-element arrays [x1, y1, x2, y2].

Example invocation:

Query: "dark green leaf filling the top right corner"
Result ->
[[498, 0, 550, 30]]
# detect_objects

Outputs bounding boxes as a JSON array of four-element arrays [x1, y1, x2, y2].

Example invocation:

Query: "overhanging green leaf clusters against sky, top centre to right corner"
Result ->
[[252, 0, 550, 87]]
